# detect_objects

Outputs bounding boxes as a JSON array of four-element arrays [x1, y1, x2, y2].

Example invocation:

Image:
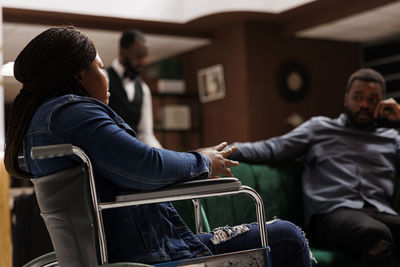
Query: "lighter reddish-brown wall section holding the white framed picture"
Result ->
[[183, 24, 249, 146]]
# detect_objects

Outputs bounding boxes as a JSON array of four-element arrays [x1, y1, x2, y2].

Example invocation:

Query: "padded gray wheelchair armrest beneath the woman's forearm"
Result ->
[[116, 177, 242, 201]]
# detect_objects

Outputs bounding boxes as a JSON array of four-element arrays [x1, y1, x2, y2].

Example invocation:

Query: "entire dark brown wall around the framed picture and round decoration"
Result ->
[[183, 22, 359, 146]]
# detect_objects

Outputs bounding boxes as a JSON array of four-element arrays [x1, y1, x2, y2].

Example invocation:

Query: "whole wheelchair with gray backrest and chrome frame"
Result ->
[[24, 144, 272, 267]]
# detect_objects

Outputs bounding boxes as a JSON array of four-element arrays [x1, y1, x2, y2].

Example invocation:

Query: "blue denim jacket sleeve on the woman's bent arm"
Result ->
[[49, 103, 211, 190]]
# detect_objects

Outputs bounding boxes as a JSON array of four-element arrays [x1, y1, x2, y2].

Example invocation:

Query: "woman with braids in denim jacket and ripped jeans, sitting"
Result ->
[[5, 26, 311, 267]]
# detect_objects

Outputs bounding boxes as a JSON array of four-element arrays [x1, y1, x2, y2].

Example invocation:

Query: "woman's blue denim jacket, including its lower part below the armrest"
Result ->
[[24, 95, 211, 263]]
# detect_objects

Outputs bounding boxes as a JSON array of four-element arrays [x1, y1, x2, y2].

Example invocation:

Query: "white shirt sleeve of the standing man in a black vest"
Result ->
[[137, 82, 162, 148]]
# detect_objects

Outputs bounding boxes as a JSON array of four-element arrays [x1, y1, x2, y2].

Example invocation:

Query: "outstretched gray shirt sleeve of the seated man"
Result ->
[[230, 119, 313, 163]]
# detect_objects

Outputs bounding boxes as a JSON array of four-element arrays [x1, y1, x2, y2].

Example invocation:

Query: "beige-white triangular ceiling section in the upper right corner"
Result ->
[[296, 1, 400, 42]]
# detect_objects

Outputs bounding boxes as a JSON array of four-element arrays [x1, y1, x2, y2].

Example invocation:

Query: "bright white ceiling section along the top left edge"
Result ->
[[1, 0, 315, 23]]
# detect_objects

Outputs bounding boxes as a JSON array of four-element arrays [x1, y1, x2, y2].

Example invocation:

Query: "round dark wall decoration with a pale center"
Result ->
[[276, 61, 308, 101]]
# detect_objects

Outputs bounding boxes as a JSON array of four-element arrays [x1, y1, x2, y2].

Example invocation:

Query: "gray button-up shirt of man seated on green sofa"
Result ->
[[230, 114, 400, 223]]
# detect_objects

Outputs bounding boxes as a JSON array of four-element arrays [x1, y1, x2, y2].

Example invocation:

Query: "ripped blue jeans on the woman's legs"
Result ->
[[198, 220, 311, 267]]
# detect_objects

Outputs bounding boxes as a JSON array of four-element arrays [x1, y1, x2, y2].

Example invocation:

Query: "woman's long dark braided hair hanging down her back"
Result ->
[[4, 26, 96, 178]]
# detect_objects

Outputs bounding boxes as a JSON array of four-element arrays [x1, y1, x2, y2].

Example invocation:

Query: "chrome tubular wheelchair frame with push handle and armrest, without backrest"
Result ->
[[31, 144, 272, 267]]
